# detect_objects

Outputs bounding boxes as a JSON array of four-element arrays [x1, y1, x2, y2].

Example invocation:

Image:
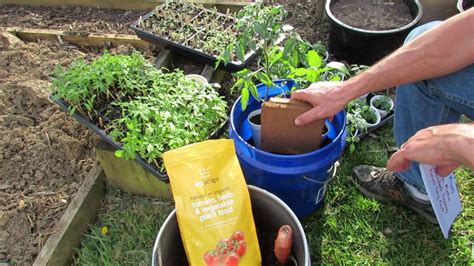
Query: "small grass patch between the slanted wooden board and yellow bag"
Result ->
[[74, 187, 174, 265]]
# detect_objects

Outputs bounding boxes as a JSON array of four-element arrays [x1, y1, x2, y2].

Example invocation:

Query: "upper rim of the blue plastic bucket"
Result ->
[[229, 79, 347, 159]]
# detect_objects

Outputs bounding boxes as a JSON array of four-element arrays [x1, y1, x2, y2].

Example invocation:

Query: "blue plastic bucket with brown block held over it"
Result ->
[[230, 80, 346, 218]]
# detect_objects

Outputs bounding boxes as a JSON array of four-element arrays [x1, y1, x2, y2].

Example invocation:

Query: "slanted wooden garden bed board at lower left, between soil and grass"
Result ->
[[33, 166, 105, 265]]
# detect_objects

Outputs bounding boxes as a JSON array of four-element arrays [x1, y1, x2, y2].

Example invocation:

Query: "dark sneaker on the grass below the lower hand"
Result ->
[[351, 165, 438, 224]]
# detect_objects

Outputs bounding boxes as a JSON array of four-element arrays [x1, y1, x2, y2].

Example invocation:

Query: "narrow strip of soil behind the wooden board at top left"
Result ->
[[0, 5, 149, 35]]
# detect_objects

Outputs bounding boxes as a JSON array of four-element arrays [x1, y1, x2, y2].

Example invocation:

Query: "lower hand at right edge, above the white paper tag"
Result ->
[[387, 124, 474, 176]]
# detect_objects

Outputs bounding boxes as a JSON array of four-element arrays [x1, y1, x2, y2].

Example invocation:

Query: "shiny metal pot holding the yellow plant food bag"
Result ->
[[152, 186, 311, 266]]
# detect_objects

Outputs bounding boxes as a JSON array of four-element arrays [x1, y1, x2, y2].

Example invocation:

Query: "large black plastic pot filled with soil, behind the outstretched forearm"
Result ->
[[325, 0, 423, 65]]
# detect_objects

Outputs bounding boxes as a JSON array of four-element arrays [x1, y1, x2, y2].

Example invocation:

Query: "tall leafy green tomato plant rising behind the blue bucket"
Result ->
[[216, 4, 349, 110]]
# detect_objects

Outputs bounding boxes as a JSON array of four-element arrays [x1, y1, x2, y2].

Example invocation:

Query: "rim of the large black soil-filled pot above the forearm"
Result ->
[[325, 0, 423, 35]]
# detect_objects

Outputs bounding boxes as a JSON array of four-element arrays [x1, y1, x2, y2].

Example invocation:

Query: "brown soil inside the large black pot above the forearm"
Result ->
[[331, 0, 414, 30]]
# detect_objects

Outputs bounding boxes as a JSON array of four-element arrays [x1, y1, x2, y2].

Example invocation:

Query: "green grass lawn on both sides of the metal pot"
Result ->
[[75, 121, 474, 265]]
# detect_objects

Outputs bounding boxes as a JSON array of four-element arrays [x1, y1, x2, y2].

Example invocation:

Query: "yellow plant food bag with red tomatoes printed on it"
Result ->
[[163, 139, 261, 266]]
